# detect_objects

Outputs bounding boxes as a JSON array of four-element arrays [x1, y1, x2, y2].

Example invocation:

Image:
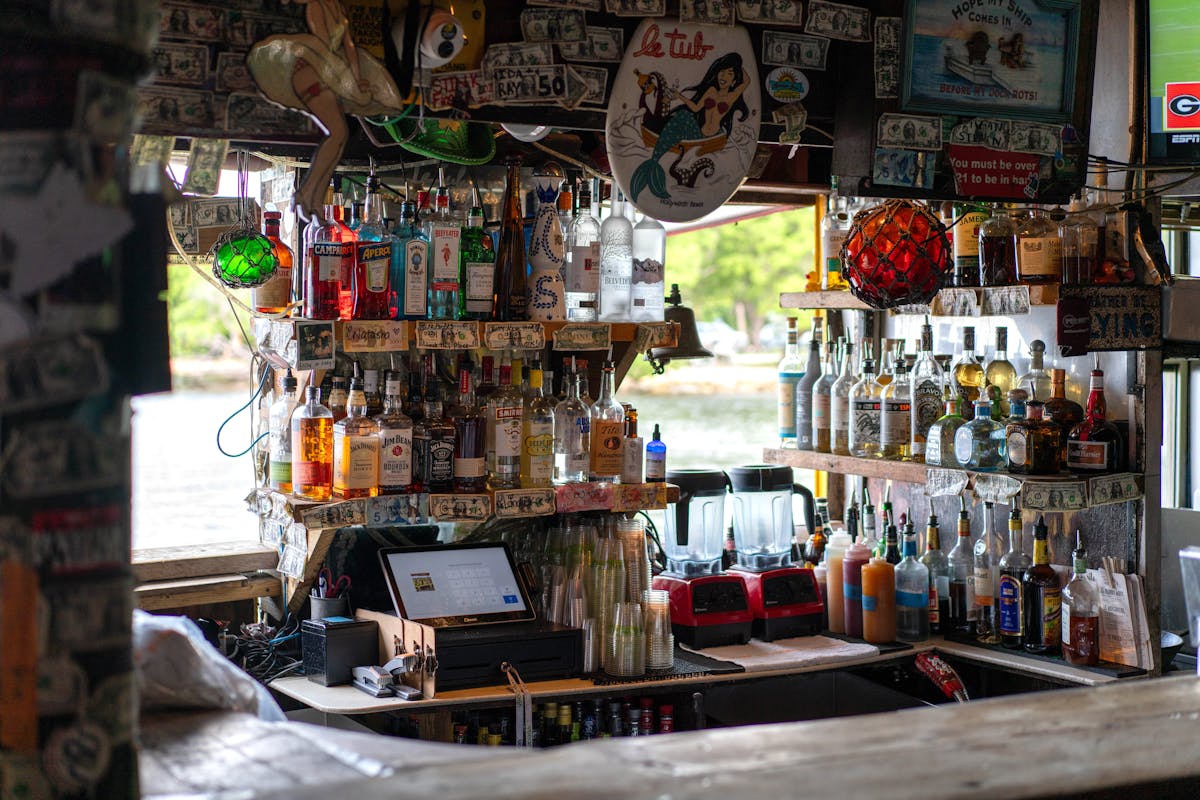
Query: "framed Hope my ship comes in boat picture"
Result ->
[[901, 0, 1081, 122]]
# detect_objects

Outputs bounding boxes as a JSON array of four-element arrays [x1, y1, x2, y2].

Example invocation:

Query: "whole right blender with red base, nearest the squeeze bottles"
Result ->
[[730, 464, 824, 642]]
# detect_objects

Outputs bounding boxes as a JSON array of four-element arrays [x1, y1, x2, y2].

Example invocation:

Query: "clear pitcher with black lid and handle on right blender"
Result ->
[[728, 464, 816, 572]]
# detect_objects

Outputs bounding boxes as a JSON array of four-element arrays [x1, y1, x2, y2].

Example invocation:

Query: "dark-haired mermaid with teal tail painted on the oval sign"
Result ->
[[629, 53, 750, 200]]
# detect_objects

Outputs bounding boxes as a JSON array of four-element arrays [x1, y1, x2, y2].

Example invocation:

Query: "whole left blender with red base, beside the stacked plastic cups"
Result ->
[[652, 469, 754, 648]]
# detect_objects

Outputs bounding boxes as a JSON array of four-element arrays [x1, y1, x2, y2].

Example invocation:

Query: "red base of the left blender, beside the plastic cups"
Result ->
[[650, 573, 754, 650]]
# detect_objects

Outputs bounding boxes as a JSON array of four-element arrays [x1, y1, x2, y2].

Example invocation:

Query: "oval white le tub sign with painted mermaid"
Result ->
[[605, 19, 762, 222]]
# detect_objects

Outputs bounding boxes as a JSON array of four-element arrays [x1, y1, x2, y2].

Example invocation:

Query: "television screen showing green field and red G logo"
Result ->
[[1146, 0, 1200, 164]]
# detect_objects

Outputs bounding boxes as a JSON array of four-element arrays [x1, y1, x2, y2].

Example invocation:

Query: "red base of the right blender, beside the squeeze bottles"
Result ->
[[724, 566, 824, 642]]
